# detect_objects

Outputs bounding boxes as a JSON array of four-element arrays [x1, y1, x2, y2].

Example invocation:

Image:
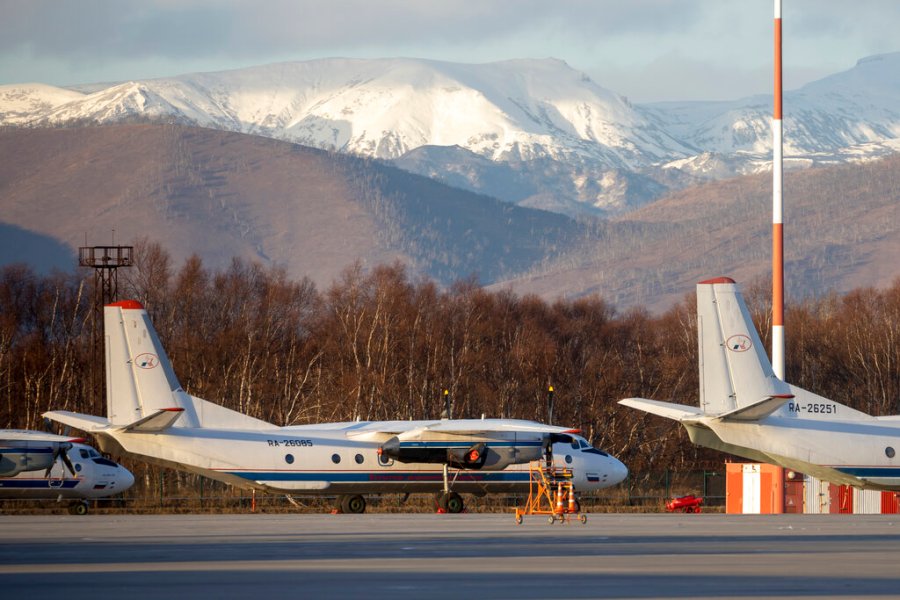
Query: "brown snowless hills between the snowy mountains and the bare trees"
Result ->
[[0, 124, 900, 311]]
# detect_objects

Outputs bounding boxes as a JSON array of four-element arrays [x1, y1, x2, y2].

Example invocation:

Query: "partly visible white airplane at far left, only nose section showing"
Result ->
[[0, 429, 134, 515]]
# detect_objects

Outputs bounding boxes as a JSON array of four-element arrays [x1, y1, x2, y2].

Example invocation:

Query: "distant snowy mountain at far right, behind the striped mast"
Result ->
[[643, 52, 900, 174]]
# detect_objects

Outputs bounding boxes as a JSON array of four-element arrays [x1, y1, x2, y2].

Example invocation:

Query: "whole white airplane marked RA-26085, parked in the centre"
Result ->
[[45, 300, 628, 513]]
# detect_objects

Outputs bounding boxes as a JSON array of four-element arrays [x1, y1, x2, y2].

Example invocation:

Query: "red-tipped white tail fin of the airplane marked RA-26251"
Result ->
[[697, 277, 792, 419]]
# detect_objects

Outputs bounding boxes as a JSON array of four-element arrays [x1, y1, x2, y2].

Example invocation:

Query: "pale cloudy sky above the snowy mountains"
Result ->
[[0, 0, 900, 102]]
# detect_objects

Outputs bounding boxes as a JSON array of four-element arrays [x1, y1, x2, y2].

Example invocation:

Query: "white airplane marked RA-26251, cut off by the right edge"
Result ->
[[619, 277, 900, 490]]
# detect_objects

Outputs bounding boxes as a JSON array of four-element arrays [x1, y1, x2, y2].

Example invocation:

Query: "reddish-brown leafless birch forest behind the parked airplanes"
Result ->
[[0, 240, 900, 496]]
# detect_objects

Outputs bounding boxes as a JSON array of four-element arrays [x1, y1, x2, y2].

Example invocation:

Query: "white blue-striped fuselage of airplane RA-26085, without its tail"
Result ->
[[98, 424, 627, 495]]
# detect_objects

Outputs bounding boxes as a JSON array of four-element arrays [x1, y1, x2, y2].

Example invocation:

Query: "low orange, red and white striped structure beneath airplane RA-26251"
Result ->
[[725, 463, 900, 514]]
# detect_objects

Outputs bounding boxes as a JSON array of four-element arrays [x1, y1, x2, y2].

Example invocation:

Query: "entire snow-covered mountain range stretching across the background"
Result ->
[[0, 53, 900, 214]]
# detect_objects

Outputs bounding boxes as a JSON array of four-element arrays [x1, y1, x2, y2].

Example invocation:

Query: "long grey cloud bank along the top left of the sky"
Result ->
[[0, 0, 692, 60]]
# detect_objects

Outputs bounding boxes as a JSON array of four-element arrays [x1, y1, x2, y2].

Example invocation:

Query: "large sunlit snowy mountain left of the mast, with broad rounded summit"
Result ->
[[0, 59, 686, 167]]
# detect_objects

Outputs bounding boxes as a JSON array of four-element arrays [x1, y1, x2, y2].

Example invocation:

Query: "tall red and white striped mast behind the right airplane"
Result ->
[[772, 0, 784, 380]]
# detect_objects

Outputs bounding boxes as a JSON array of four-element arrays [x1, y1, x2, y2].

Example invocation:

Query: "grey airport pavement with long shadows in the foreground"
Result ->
[[0, 514, 900, 600]]
